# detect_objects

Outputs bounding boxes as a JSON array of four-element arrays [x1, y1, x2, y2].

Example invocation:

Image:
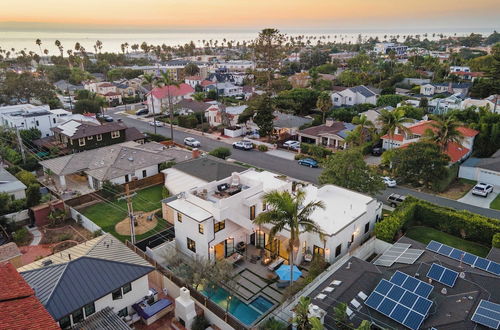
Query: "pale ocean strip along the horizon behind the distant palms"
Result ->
[[0, 29, 493, 55]]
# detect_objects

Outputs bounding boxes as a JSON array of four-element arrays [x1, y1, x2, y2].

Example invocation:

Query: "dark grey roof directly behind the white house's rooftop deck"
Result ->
[[174, 156, 247, 182]]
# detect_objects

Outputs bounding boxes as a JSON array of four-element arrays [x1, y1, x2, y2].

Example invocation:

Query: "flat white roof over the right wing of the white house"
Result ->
[[303, 185, 373, 235]]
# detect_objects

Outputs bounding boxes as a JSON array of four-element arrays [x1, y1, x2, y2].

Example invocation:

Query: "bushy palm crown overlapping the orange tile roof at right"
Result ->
[[424, 116, 464, 152]]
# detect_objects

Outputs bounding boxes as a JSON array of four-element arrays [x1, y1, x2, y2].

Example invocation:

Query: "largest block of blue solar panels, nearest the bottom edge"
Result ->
[[365, 279, 432, 330]]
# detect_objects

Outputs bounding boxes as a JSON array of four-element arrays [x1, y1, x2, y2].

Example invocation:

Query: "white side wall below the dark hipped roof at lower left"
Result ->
[[94, 275, 149, 313]]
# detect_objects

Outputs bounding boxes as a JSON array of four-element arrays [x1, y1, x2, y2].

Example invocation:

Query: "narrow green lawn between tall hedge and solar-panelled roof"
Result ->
[[406, 227, 490, 257]]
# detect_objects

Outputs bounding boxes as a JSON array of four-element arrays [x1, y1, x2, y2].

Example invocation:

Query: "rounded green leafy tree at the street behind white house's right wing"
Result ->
[[319, 148, 384, 194]]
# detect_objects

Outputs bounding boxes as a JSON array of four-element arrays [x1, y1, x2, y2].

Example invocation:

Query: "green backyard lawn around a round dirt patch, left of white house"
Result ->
[[81, 185, 167, 241]]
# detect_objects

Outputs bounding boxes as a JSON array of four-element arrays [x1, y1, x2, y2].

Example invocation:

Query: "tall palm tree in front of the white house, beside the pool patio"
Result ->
[[254, 190, 325, 285]]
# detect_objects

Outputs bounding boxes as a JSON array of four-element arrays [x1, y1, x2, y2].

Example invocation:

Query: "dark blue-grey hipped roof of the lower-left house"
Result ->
[[21, 257, 154, 320]]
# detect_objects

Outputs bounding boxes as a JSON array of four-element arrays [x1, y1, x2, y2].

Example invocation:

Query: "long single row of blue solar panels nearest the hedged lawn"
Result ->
[[427, 241, 500, 276]]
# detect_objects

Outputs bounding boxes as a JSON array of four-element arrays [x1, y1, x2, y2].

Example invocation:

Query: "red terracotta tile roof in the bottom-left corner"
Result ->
[[0, 263, 60, 330]]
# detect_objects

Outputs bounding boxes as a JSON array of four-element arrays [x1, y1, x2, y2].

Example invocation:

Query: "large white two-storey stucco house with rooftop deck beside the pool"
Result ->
[[164, 169, 382, 263]]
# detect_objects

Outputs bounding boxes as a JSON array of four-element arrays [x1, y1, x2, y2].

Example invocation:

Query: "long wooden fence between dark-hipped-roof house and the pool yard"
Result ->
[[125, 241, 251, 330]]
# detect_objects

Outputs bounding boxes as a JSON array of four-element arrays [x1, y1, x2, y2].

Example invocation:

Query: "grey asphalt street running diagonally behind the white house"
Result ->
[[107, 109, 500, 219]]
